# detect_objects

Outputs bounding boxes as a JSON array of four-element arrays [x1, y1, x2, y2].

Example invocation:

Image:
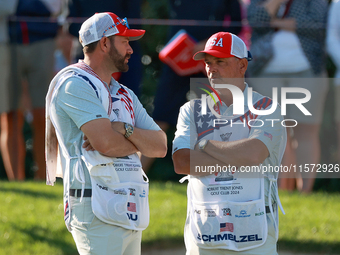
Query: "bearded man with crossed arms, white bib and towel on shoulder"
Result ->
[[46, 12, 167, 255]]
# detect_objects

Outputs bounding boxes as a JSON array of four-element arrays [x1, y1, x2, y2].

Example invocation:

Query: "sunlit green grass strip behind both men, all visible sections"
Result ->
[[0, 181, 340, 255]]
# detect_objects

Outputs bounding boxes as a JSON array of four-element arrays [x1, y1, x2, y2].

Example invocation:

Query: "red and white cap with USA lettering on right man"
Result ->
[[193, 32, 252, 61]]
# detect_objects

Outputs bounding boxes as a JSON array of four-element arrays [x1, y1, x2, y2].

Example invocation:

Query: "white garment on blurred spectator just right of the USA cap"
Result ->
[[264, 30, 310, 73]]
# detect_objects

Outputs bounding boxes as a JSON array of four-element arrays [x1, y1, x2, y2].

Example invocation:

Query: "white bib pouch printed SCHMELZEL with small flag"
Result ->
[[185, 176, 268, 251]]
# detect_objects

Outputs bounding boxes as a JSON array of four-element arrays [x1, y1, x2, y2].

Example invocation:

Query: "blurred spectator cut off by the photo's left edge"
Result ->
[[0, 0, 18, 181]]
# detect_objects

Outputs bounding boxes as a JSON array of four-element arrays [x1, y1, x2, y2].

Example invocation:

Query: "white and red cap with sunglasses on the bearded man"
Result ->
[[79, 12, 145, 47]]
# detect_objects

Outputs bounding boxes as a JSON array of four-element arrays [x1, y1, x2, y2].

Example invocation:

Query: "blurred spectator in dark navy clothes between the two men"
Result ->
[[142, 0, 242, 171]]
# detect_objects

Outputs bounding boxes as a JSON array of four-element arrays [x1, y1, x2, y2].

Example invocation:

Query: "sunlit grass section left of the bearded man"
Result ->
[[0, 182, 75, 255]]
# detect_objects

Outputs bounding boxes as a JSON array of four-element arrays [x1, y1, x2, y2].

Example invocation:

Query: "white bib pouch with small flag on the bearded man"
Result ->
[[91, 173, 149, 230]]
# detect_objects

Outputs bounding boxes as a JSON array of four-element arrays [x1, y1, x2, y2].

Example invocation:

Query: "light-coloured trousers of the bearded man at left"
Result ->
[[70, 197, 142, 255]]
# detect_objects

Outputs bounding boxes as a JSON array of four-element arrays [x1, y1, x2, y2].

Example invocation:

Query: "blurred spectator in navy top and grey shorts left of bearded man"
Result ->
[[1, 0, 61, 180]]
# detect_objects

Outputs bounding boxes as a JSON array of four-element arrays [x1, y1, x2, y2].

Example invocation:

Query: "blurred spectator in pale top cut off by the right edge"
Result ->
[[327, 0, 340, 162]]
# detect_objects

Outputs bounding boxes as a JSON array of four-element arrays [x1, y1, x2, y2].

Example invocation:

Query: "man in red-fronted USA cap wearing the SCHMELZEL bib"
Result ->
[[173, 32, 286, 255]]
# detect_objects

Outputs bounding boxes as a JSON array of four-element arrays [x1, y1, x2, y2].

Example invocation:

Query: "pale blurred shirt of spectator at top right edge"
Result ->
[[326, 0, 340, 86]]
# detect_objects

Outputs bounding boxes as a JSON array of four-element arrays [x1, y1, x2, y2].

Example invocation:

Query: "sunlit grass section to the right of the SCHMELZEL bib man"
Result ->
[[279, 192, 340, 254]]
